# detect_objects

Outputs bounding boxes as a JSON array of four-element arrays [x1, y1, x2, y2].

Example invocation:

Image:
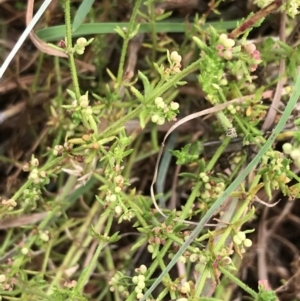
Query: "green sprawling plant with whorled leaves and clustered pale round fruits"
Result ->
[[0, 0, 300, 301]]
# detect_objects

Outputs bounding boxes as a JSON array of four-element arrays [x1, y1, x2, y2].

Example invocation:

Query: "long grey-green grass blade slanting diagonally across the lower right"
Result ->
[[140, 75, 300, 301]]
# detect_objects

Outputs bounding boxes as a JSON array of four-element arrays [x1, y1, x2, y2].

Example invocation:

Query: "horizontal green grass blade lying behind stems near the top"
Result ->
[[36, 20, 237, 42]]
